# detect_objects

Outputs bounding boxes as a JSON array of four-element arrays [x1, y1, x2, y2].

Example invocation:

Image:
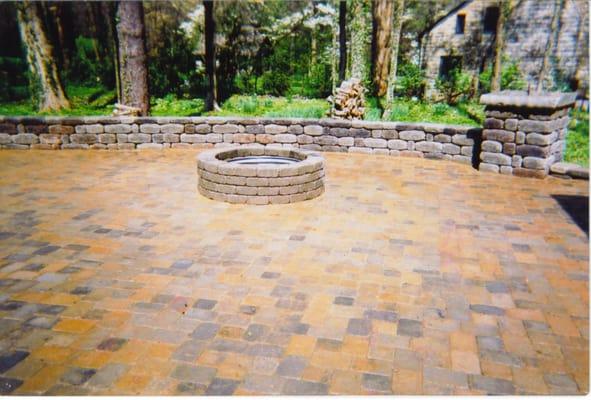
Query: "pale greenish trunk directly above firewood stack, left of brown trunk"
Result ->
[[351, 0, 371, 86]]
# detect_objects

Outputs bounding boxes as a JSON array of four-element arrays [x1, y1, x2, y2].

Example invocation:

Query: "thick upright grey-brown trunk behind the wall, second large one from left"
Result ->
[[117, 1, 150, 115]]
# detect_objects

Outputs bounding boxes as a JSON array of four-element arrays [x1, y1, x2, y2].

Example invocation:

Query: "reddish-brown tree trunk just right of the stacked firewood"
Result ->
[[372, 0, 393, 103]]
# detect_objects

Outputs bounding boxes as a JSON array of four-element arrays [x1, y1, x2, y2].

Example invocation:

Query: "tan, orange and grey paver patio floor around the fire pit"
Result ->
[[0, 150, 589, 394]]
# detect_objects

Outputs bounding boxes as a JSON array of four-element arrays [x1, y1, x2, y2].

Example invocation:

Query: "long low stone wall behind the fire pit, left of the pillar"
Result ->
[[0, 117, 481, 166]]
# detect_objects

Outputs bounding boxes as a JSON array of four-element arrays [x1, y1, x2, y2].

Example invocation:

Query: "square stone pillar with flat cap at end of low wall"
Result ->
[[479, 91, 576, 178]]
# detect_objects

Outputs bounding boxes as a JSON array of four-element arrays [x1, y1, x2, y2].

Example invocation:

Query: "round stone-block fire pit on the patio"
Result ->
[[197, 147, 324, 204]]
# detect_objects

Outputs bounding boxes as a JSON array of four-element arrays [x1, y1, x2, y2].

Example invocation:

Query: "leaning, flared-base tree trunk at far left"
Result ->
[[15, 1, 70, 111]]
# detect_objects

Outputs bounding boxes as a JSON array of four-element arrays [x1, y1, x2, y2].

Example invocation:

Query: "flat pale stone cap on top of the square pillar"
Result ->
[[480, 90, 577, 109]]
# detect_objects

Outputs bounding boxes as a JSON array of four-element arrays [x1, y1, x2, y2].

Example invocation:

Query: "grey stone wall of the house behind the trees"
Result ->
[[421, 0, 589, 98]]
